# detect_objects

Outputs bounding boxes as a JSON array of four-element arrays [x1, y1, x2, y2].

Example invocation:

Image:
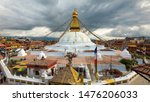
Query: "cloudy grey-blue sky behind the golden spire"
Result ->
[[0, 0, 150, 36]]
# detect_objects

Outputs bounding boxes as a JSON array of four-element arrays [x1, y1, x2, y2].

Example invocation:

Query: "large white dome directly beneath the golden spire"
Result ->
[[58, 32, 95, 46]]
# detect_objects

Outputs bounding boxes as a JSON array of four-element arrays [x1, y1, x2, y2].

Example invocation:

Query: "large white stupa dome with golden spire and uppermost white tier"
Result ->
[[45, 10, 108, 54]]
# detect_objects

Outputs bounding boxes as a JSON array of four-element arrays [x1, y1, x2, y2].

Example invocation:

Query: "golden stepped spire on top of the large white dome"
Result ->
[[70, 9, 80, 32]]
